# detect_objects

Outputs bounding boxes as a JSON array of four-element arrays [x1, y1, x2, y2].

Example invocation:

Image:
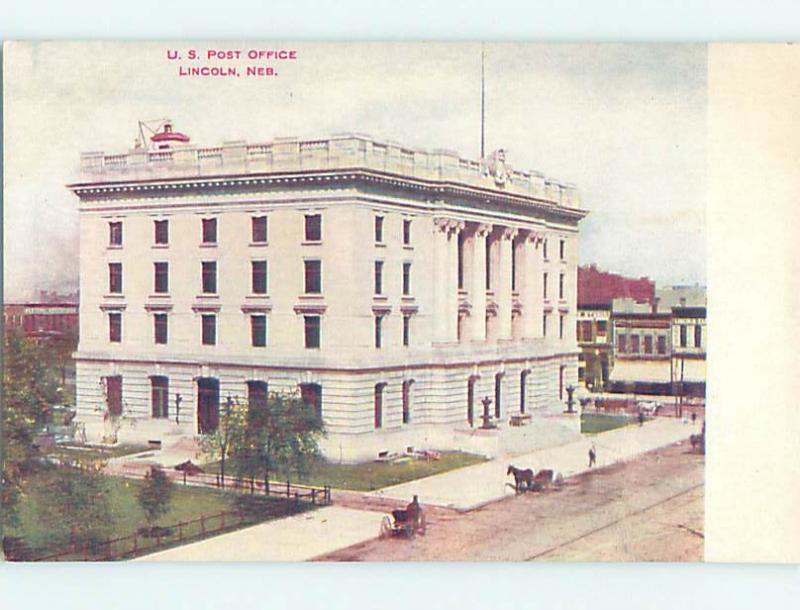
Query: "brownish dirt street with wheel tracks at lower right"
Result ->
[[318, 442, 704, 561]]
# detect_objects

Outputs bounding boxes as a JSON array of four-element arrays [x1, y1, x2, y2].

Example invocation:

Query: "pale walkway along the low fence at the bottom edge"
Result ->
[[135, 506, 381, 561]]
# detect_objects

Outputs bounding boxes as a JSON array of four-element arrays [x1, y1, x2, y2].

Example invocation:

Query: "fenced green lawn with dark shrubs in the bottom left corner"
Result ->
[[4, 468, 306, 557]]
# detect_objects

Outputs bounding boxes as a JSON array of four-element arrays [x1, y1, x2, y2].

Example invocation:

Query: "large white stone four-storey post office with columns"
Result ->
[[70, 125, 586, 460]]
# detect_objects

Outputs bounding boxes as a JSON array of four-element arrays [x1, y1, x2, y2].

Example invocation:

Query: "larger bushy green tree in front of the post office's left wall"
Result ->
[[235, 392, 325, 489]]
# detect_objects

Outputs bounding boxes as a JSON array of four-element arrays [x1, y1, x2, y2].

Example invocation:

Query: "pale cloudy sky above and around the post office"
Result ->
[[4, 42, 706, 298]]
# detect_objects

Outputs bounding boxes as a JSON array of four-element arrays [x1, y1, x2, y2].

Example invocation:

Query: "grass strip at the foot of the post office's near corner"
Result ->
[[203, 451, 486, 491]]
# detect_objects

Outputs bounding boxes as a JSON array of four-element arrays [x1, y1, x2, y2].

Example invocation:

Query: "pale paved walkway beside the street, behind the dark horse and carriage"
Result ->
[[372, 418, 700, 510]]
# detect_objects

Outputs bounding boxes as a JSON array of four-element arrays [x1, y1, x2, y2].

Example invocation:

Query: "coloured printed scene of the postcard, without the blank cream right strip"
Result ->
[[2, 41, 788, 561]]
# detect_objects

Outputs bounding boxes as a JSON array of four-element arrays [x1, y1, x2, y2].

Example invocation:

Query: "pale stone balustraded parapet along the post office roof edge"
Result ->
[[76, 134, 580, 208]]
